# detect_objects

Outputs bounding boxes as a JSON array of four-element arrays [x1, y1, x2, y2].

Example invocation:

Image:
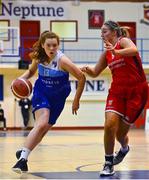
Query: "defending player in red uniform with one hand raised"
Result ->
[[81, 21, 148, 176]]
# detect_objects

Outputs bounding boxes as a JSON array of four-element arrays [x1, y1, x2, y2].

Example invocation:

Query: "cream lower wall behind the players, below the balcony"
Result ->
[[0, 68, 111, 128]]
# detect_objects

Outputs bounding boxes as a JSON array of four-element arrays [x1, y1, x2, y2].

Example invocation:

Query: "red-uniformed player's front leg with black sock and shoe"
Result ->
[[100, 112, 121, 176]]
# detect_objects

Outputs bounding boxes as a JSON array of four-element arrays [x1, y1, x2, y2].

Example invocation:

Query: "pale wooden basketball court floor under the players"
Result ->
[[0, 129, 149, 179]]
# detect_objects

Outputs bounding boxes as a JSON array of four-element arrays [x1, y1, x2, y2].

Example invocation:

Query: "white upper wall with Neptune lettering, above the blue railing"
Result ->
[[0, 0, 149, 39]]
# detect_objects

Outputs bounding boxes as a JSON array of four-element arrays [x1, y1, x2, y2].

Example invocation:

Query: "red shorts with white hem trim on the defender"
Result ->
[[105, 82, 148, 124]]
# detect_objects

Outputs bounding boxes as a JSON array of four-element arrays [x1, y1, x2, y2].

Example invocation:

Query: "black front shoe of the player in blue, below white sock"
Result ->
[[12, 158, 28, 174]]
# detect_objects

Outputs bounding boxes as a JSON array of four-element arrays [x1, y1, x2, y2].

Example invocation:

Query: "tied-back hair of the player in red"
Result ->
[[104, 20, 127, 37]]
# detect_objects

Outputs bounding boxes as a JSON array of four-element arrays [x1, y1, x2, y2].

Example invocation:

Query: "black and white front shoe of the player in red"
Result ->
[[100, 161, 115, 176]]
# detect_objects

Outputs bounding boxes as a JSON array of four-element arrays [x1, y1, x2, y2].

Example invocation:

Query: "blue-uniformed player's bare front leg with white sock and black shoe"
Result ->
[[12, 108, 52, 173]]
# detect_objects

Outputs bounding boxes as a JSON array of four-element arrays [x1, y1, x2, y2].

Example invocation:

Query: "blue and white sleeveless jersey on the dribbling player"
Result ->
[[34, 51, 71, 100]]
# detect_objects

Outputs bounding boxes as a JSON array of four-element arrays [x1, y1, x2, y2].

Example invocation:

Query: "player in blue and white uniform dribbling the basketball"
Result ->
[[12, 31, 85, 173]]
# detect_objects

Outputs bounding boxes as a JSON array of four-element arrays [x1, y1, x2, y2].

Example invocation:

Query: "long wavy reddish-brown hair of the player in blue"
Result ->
[[29, 31, 60, 63]]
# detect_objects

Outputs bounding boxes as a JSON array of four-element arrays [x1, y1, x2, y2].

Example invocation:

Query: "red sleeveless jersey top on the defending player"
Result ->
[[106, 39, 146, 86]]
